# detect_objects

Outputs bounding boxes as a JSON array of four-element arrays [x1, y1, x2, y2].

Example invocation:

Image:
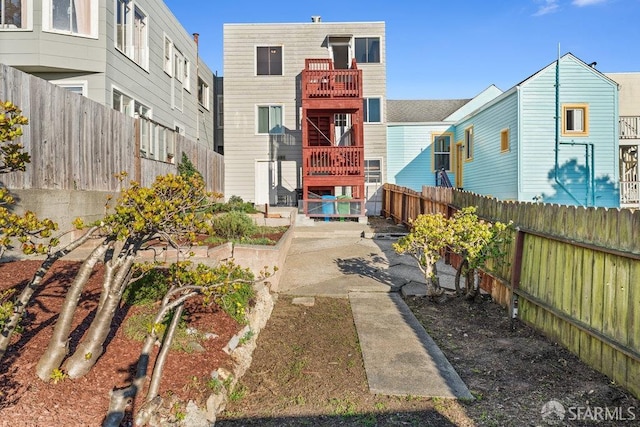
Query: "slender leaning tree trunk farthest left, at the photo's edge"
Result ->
[[0, 227, 98, 361]]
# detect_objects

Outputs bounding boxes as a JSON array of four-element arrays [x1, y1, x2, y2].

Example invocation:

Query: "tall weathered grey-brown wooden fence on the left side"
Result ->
[[0, 64, 224, 192]]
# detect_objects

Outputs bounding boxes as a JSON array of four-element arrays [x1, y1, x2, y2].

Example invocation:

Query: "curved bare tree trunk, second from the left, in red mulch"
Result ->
[[36, 240, 113, 381]]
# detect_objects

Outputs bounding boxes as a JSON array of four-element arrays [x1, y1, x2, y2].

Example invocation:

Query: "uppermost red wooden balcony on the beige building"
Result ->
[[302, 59, 362, 99]]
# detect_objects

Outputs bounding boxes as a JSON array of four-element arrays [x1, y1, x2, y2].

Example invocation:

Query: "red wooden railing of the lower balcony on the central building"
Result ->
[[302, 146, 364, 176]]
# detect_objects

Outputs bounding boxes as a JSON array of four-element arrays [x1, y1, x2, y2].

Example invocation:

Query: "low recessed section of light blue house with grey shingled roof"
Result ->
[[387, 86, 502, 191]]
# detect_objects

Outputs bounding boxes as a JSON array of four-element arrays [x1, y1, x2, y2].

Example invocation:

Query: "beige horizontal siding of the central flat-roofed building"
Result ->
[[223, 22, 386, 206]]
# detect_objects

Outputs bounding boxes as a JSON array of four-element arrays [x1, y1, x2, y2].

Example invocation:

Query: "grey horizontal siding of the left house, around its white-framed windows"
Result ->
[[0, 0, 213, 149]]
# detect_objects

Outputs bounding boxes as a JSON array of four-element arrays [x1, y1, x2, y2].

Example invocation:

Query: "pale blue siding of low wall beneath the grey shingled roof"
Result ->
[[387, 125, 455, 191]]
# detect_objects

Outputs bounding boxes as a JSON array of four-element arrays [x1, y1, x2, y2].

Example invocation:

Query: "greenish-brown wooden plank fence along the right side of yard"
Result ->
[[383, 185, 640, 397]]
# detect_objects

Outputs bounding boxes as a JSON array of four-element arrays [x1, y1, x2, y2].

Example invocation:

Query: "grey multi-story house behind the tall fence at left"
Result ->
[[0, 0, 214, 157]]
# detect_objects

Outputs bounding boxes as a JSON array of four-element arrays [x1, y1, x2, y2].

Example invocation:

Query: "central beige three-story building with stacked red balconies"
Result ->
[[224, 17, 386, 216]]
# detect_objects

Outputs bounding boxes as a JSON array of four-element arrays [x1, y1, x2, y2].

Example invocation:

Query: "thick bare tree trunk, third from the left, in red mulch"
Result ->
[[64, 254, 135, 379]]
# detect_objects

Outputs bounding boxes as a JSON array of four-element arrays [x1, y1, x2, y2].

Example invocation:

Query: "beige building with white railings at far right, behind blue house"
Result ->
[[606, 72, 640, 209]]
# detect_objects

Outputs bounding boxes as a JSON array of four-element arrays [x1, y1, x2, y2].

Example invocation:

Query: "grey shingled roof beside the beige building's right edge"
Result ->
[[387, 99, 471, 123]]
